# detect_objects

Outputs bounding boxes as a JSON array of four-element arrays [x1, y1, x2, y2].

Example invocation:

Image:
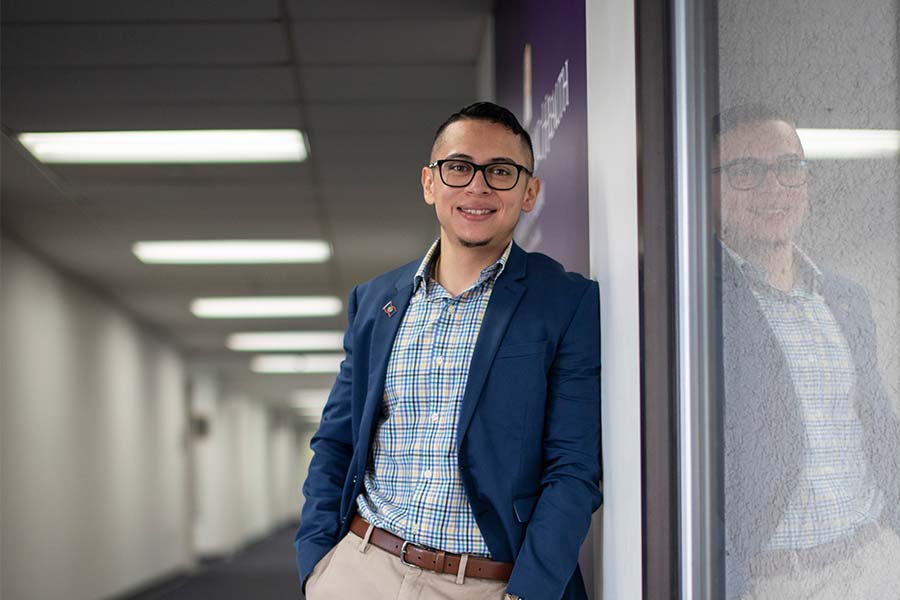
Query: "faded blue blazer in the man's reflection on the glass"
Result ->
[[719, 255, 900, 599]]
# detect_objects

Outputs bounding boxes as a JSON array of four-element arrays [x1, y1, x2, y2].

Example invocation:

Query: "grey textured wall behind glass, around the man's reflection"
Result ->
[[719, 0, 900, 398]]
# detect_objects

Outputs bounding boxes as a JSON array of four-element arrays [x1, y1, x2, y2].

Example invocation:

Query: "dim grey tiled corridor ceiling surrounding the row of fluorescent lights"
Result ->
[[0, 0, 493, 400]]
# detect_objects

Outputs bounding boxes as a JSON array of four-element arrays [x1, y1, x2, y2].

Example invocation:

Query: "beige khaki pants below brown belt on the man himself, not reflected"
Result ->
[[306, 532, 506, 600]]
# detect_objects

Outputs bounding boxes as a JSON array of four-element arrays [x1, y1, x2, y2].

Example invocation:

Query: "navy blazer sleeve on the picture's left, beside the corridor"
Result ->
[[294, 289, 357, 584]]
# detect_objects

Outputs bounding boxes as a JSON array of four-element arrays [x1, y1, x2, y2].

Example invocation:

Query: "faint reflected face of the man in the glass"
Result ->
[[713, 121, 808, 249]]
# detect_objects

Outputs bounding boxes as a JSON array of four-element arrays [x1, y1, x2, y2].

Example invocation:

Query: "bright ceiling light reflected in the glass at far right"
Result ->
[[797, 129, 900, 160]]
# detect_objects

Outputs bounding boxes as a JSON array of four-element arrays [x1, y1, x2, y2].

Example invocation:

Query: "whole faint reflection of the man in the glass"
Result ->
[[713, 106, 900, 600]]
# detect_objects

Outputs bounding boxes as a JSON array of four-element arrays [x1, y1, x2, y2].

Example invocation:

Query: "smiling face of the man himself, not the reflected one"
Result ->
[[422, 119, 540, 250]]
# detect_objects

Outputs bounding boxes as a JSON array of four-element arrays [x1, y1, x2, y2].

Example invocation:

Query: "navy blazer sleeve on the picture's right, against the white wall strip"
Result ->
[[507, 281, 602, 600]]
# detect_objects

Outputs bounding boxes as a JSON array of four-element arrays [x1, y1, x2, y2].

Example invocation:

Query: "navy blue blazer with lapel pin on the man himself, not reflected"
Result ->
[[295, 244, 602, 600]]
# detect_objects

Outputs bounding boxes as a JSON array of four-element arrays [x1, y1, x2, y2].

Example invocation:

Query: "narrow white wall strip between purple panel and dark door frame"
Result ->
[[586, 0, 642, 600]]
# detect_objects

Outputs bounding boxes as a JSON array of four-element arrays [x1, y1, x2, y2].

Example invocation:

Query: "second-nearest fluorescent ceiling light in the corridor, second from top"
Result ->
[[132, 240, 331, 265]]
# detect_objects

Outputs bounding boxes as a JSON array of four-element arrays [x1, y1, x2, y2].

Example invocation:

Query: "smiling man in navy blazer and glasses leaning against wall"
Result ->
[[296, 102, 601, 600]]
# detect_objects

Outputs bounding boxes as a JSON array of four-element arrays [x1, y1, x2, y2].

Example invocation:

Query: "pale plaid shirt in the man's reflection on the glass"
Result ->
[[729, 248, 884, 550]]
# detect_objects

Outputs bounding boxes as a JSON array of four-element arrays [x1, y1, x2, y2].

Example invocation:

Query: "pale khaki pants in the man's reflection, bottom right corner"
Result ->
[[744, 529, 900, 600]]
